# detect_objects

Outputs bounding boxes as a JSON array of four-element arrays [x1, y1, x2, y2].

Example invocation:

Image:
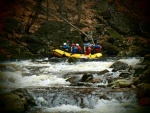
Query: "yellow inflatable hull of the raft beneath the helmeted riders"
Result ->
[[53, 49, 102, 59]]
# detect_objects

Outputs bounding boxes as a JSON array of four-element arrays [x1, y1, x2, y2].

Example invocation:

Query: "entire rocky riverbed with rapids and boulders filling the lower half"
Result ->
[[0, 58, 150, 113]]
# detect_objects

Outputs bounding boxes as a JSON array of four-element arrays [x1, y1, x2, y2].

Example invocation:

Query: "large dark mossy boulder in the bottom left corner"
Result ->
[[0, 89, 36, 113]]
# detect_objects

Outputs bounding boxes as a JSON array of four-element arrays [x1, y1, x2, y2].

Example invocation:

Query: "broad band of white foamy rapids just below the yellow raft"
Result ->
[[0, 60, 113, 88]]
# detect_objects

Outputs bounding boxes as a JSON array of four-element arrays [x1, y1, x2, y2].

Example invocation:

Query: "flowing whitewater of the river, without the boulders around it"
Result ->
[[0, 58, 148, 113]]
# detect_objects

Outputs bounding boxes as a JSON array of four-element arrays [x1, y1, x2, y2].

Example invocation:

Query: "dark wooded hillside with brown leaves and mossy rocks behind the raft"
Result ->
[[0, 0, 150, 60]]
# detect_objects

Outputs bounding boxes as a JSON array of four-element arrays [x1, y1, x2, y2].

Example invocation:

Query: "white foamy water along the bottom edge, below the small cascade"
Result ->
[[39, 99, 142, 113]]
